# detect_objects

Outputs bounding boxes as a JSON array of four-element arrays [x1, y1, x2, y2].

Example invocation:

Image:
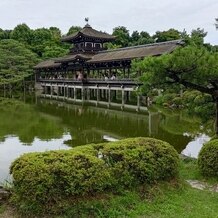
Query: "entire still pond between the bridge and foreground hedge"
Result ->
[[0, 98, 212, 184]]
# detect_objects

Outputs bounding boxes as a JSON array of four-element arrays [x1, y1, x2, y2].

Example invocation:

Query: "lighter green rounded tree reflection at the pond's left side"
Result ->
[[0, 99, 63, 145]]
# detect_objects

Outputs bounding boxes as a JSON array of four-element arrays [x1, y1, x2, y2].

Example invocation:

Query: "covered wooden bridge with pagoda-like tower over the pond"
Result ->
[[34, 24, 182, 108]]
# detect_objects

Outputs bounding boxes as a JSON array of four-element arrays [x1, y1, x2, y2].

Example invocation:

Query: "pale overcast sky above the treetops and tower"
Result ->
[[0, 0, 218, 44]]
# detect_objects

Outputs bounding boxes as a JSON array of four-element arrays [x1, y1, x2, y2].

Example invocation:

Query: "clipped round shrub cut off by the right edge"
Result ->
[[198, 139, 218, 178]]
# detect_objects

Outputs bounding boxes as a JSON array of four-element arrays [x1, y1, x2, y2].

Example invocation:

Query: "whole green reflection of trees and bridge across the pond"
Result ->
[[0, 99, 209, 151]]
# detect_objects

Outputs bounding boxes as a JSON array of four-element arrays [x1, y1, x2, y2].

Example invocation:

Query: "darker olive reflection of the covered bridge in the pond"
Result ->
[[38, 100, 203, 151]]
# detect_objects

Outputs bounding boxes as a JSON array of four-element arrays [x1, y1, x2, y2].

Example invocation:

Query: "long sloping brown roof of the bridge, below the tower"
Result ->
[[34, 40, 183, 69]]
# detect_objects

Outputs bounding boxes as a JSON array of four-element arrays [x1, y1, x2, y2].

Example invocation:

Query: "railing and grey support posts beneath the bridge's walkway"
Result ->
[[36, 79, 147, 111]]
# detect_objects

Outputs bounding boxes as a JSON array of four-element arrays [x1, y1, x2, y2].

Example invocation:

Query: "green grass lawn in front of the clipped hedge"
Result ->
[[58, 181, 218, 218]]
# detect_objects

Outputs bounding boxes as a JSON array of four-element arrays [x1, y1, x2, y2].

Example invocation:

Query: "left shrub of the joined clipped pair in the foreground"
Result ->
[[11, 150, 110, 212]]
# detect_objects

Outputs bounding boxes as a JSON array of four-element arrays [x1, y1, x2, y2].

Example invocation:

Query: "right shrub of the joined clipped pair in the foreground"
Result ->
[[94, 138, 178, 187]]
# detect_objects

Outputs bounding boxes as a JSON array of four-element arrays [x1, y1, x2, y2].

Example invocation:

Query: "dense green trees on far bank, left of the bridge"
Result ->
[[0, 24, 69, 86]]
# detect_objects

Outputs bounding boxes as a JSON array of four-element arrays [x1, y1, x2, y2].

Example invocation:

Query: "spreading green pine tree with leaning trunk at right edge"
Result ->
[[134, 45, 218, 134]]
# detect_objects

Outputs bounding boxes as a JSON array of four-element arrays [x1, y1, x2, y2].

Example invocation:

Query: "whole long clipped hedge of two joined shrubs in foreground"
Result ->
[[11, 138, 178, 212]]
